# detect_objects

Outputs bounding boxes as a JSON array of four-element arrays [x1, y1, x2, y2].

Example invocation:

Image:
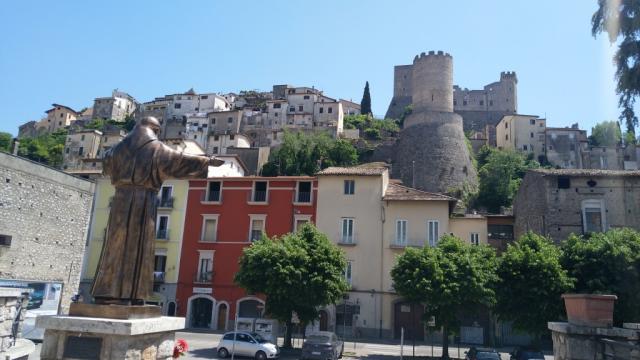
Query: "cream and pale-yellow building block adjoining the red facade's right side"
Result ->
[[316, 164, 487, 338]]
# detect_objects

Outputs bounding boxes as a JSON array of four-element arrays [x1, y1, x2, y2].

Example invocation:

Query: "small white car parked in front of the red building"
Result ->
[[218, 331, 280, 360]]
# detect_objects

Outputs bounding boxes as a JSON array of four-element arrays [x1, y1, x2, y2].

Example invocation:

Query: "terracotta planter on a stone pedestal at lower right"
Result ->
[[562, 294, 618, 328]]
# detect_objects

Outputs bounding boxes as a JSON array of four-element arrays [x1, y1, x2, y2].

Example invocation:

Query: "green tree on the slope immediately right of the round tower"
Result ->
[[478, 150, 540, 212]]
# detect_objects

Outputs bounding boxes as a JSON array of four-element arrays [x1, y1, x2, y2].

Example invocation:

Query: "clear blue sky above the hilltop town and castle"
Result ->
[[0, 0, 618, 135]]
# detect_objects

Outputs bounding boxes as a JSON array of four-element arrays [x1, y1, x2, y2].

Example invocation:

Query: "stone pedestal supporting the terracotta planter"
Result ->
[[548, 322, 640, 360]]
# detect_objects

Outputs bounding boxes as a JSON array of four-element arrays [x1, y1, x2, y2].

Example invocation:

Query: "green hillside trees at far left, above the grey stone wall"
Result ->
[[18, 130, 67, 167]]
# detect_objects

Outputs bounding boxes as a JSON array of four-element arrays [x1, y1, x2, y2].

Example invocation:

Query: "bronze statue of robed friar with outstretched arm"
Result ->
[[91, 117, 224, 305]]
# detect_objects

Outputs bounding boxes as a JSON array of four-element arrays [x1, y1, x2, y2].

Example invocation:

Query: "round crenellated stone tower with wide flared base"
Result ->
[[393, 51, 478, 195]]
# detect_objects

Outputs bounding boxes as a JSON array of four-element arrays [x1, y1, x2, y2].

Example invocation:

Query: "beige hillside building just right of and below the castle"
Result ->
[[496, 114, 547, 160]]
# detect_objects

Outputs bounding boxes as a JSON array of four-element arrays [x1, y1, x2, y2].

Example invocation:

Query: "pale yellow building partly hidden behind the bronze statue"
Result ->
[[80, 177, 189, 315]]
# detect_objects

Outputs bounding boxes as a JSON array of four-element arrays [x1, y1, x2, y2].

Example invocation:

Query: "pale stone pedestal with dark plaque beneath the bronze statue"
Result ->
[[36, 316, 185, 360]]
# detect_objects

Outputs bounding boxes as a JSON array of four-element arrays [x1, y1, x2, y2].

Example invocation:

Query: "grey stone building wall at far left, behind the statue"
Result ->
[[0, 152, 94, 313]]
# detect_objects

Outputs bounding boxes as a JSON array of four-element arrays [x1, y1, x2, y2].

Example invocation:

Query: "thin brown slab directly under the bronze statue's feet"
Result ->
[[69, 303, 162, 320]]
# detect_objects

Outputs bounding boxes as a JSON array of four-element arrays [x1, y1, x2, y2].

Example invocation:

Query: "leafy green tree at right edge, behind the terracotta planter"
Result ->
[[561, 229, 640, 326]]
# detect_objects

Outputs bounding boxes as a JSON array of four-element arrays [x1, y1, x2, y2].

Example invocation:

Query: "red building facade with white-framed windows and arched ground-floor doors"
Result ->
[[176, 176, 318, 330]]
